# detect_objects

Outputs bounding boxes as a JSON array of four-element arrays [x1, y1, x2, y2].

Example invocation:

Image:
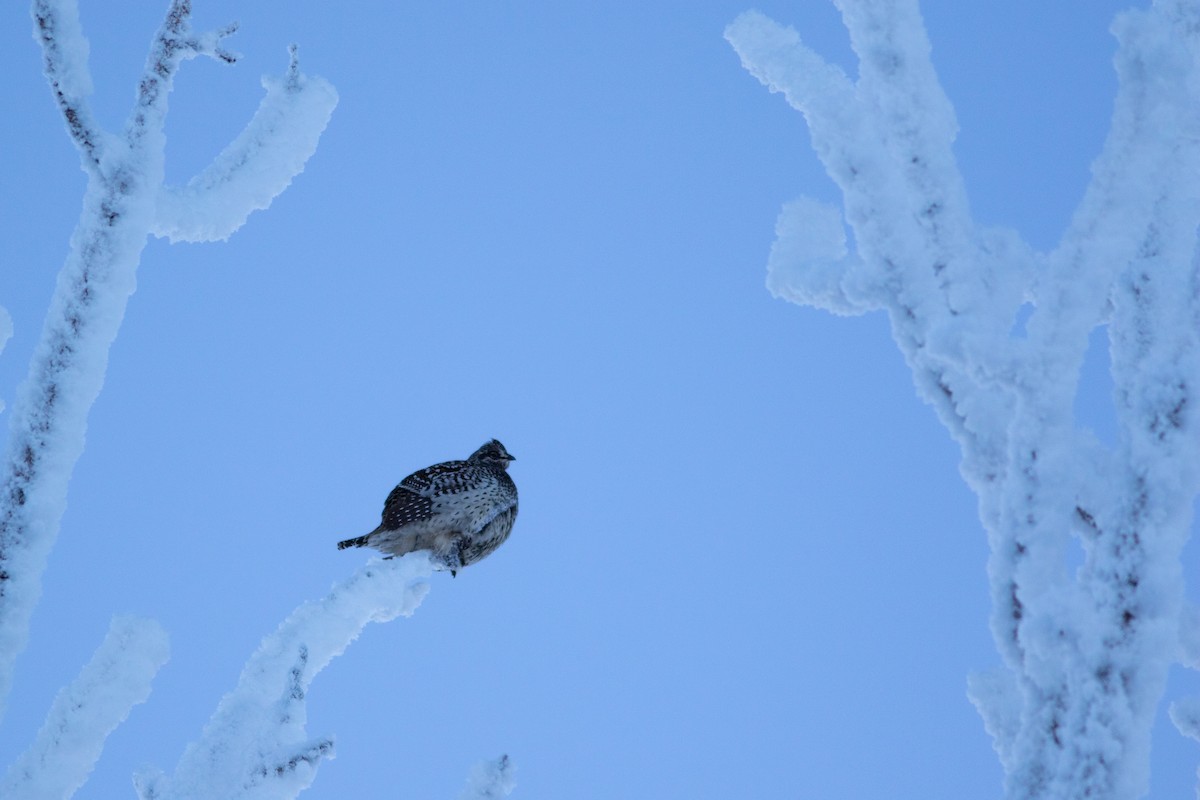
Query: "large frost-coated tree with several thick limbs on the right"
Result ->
[[726, 0, 1200, 798]]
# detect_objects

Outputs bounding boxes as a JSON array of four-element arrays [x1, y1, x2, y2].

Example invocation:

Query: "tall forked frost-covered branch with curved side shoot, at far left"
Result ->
[[0, 0, 336, 724]]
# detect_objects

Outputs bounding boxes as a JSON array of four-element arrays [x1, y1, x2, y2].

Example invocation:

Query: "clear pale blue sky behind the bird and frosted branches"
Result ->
[[0, 0, 1196, 799]]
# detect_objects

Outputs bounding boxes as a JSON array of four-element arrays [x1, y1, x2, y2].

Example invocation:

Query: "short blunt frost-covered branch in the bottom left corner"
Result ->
[[0, 616, 169, 800]]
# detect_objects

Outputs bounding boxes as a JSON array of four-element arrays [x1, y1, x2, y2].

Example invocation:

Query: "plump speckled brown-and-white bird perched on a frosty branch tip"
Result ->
[[337, 439, 517, 577]]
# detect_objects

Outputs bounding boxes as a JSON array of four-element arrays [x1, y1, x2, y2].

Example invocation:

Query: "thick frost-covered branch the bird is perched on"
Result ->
[[136, 552, 433, 800]]
